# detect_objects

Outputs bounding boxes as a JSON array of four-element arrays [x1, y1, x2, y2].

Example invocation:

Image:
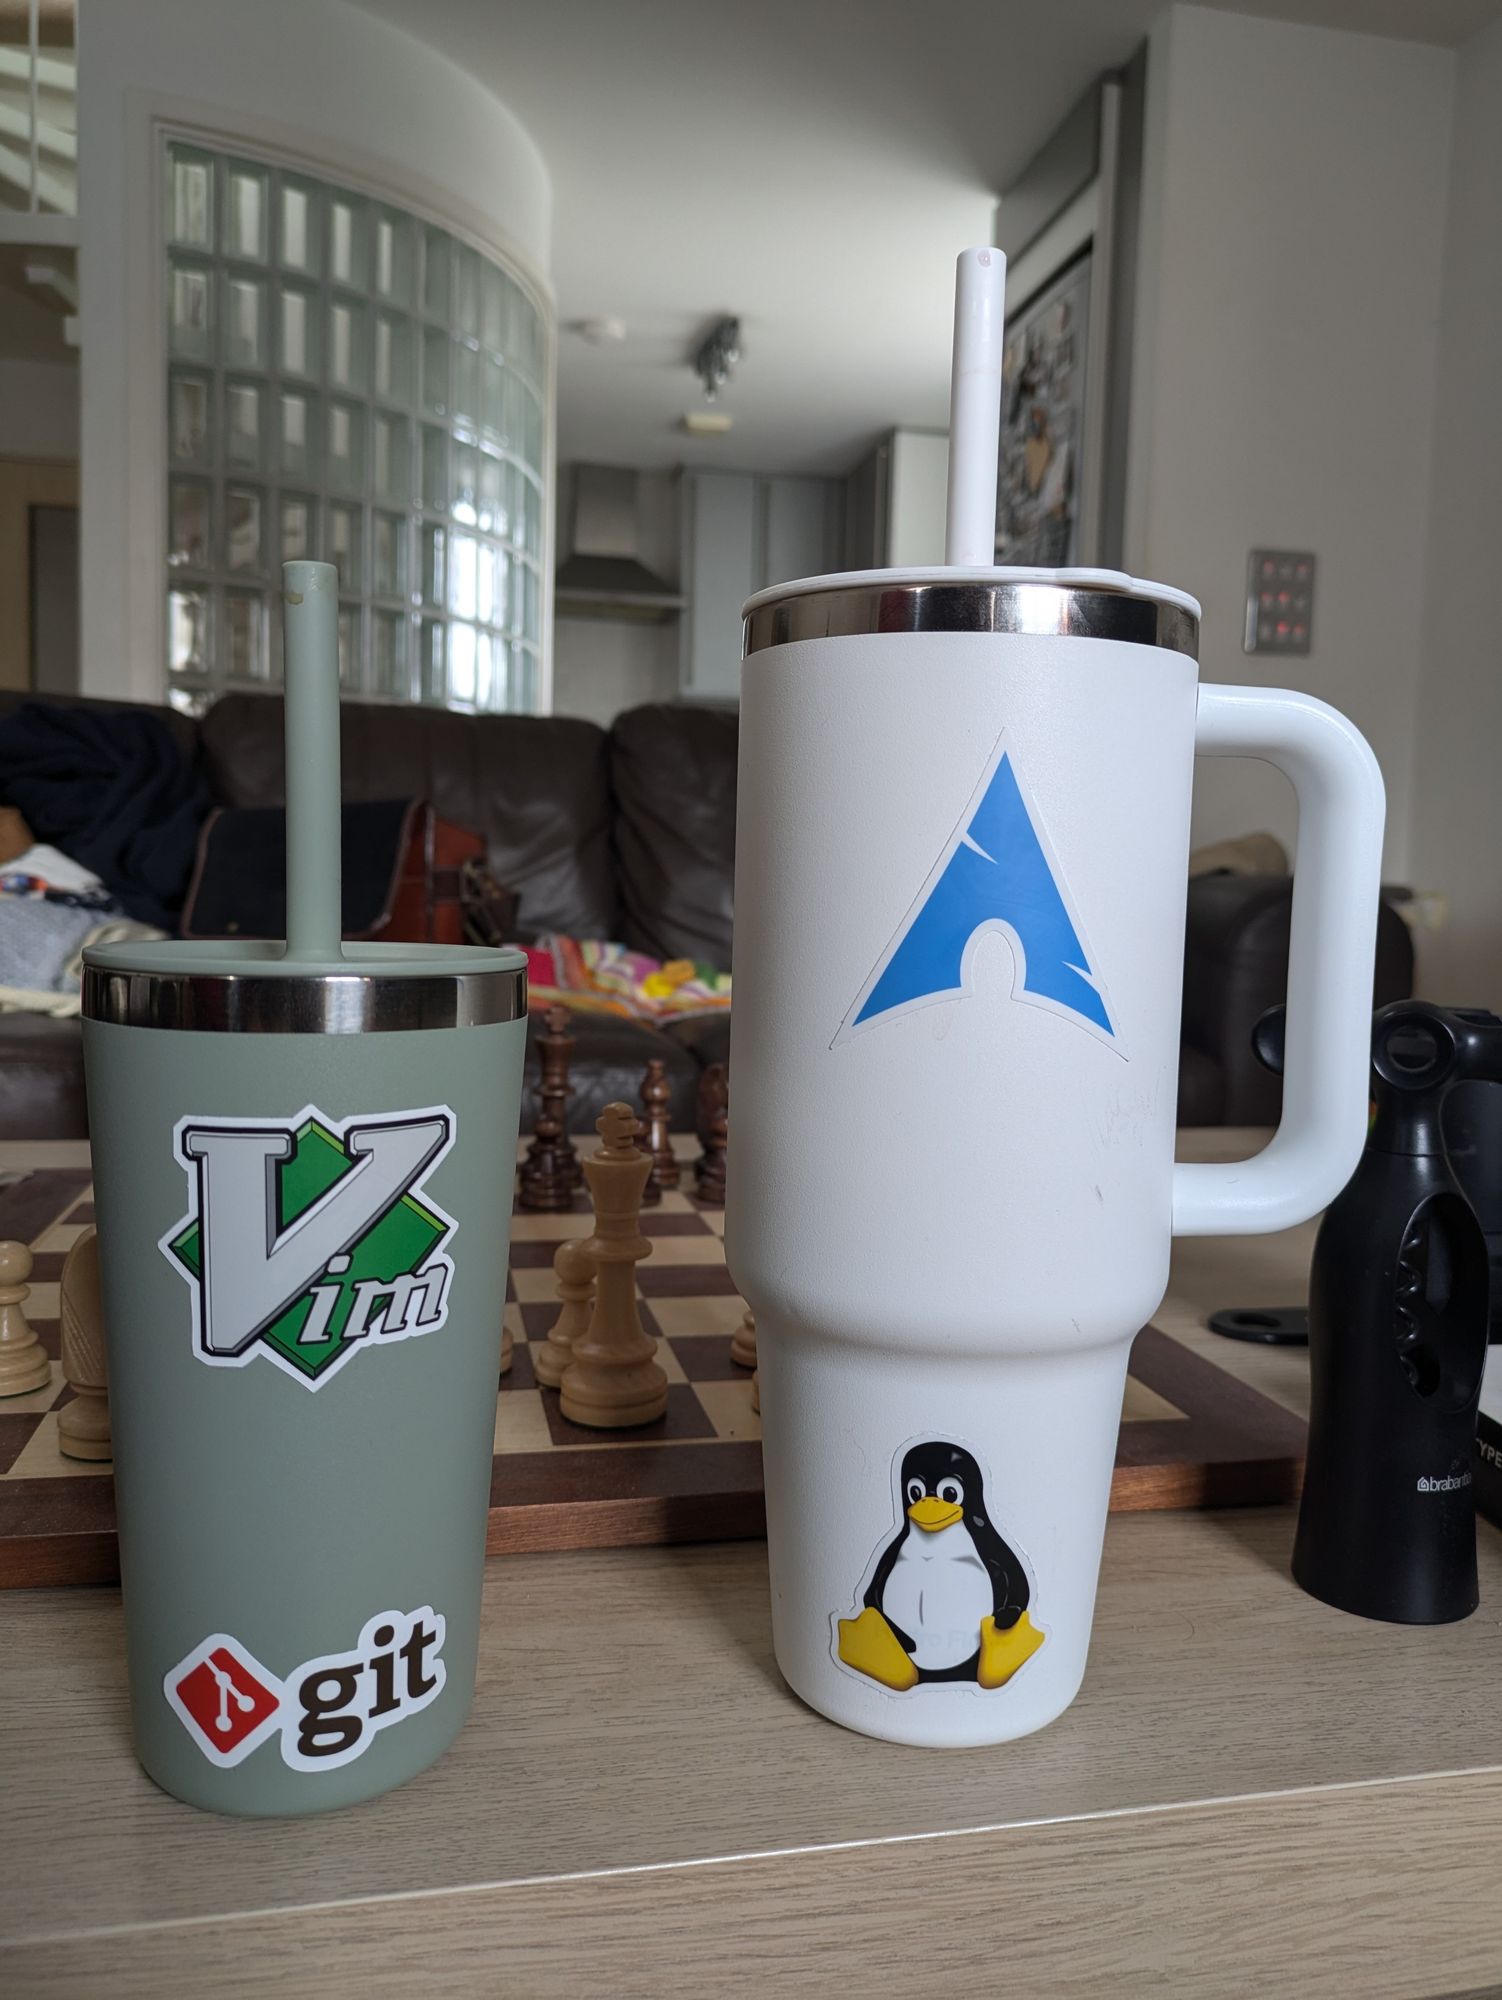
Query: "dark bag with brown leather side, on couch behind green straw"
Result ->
[[182, 798, 516, 944]]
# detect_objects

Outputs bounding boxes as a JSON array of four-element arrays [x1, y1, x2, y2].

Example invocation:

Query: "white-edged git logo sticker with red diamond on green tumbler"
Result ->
[[162, 1604, 448, 1770]]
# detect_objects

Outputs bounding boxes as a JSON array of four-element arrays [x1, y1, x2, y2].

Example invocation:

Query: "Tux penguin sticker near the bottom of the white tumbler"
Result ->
[[834, 1438, 1048, 1694]]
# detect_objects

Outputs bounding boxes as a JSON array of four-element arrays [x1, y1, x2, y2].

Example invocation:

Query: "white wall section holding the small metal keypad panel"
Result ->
[[1126, 6, 1464, 878]]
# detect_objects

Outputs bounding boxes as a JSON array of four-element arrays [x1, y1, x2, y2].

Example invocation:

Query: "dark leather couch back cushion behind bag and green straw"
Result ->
[[202, 694, 618, 938]]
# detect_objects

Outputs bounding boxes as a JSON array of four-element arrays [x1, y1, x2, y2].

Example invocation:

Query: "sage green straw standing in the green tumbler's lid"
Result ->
[[282, 562, 344, 964]]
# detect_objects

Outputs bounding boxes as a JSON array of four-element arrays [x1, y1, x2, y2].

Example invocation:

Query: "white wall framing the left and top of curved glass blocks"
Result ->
[[78, 0, 552, 700]]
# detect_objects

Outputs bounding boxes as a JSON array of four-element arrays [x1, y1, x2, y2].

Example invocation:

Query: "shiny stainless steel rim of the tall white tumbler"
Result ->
[[744, 580, 1200, 660]]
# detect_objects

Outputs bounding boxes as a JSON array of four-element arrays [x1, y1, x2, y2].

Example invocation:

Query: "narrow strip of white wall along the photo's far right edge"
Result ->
[[1412, 22, 1502, 1008]]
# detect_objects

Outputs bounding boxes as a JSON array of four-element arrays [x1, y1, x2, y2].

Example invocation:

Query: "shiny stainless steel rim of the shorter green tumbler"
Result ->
[[84, 966, 526, 1034]]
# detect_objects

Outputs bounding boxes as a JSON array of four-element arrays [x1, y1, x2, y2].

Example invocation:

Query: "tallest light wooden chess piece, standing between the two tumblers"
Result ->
[[558, 1104, 668, 1430]]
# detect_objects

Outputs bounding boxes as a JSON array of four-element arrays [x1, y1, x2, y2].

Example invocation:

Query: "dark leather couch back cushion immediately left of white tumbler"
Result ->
[[610, 702, 740, 970]]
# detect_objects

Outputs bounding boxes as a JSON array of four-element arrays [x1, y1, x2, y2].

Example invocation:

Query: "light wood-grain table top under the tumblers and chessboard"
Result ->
[[0, 1134, 1502, 2000]]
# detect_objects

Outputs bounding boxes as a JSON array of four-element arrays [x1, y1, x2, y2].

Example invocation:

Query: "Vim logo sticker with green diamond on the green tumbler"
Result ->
[[158, 1104, 456, 1390]]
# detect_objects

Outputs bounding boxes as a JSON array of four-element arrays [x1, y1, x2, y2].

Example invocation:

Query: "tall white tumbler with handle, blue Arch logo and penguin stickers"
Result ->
[[726, 568, 1384, 1744]]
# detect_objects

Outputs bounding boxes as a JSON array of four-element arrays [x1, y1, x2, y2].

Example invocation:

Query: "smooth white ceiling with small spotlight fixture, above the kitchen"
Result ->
[[360, 0, 1502, 472]]
